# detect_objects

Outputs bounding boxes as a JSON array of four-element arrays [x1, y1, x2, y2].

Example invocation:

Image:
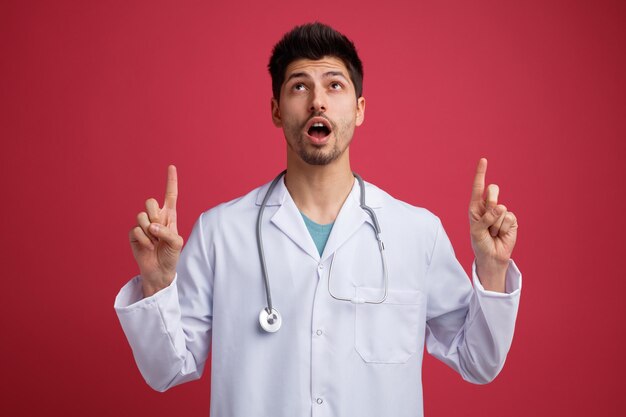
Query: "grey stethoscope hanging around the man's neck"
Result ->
[[256, 170, 389, 333]]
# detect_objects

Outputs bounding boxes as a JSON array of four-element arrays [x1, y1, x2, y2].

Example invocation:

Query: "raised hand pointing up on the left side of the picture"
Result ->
[[129, 165, 183, 297]]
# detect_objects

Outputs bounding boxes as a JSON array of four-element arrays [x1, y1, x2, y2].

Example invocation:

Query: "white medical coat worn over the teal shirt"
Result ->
[[115, 181, 521, 417]]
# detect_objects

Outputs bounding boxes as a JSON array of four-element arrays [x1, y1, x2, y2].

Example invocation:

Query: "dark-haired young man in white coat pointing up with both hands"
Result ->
[[115, 24, 521, 417]]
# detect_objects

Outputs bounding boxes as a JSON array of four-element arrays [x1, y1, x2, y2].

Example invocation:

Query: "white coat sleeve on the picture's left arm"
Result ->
[[114, 216, 213, 391]]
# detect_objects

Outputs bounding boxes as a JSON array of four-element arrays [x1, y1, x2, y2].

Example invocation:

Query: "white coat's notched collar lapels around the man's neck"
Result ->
[[256, 172, 383, 261]]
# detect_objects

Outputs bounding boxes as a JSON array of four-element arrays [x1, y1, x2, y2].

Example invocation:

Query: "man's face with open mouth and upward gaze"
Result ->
[[272, 57, 365, 165]]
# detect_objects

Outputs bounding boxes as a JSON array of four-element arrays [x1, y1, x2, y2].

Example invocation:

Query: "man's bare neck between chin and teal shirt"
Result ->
[[285, 150, 354, 224]]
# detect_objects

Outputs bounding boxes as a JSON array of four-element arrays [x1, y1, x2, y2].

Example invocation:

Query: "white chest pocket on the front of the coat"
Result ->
[[355, 287, 426, 363]]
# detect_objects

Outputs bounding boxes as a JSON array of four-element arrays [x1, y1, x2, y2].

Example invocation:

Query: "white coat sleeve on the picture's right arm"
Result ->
[[426, 223, 522, 384]]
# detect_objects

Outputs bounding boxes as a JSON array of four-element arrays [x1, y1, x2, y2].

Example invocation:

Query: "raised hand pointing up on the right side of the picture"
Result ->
[[469, 158, 517, 292]]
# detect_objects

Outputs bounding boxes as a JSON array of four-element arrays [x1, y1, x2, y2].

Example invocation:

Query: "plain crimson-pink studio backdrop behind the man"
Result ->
[[0, 0, 626, 417]]
